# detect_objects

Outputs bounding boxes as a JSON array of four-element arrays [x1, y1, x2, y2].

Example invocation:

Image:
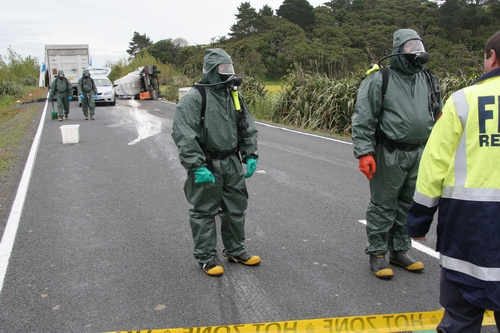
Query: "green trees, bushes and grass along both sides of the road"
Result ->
[[0, 0, 500, 176]]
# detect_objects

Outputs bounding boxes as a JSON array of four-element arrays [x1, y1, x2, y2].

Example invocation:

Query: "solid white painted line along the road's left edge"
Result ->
[[0, 93, 49, 293]]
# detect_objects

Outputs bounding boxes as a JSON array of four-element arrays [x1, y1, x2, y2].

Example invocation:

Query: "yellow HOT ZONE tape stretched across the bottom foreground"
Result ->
[[109, 310, 495, 333]]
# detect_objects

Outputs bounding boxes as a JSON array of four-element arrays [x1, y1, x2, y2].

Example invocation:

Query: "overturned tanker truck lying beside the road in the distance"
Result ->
[[114, 66, 161, 99]]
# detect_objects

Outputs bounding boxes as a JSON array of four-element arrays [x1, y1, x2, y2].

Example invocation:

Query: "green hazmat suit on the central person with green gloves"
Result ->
[[172, 49, 258, 264]]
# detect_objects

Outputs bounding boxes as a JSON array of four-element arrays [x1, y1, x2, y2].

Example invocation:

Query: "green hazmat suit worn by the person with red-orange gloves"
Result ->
[[352, 29, 443, 255]]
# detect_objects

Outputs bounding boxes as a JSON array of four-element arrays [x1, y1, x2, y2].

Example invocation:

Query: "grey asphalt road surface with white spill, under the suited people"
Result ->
[[0, 100, 492, 332]]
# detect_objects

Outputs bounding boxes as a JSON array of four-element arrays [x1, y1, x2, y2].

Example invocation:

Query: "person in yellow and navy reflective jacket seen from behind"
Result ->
[[407, 31, 500, 333]]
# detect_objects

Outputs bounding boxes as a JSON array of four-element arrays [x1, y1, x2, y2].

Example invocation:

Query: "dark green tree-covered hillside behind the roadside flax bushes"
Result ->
[[121, 0, 500, 80]]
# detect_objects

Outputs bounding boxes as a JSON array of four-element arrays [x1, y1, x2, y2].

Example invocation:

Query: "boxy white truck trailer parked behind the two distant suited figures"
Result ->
[[39, 44, 90, 95]]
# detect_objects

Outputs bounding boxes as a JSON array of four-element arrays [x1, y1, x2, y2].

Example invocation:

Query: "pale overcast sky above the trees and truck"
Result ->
[[0, 0, 326, 66]]
